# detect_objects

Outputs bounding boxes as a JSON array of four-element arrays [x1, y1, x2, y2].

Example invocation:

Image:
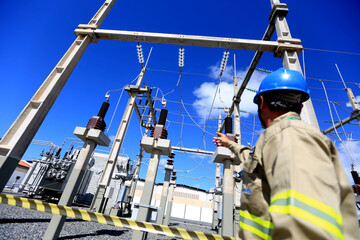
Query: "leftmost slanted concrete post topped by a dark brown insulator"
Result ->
[[43, 103, 110, 240]]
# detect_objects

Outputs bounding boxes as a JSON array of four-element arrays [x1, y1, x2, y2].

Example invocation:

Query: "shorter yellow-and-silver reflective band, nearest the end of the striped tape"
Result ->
[[239, 211, 274, 240]]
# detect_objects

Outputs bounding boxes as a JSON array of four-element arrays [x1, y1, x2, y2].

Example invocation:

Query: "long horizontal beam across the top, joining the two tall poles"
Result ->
[[75, 29, 302, 52]]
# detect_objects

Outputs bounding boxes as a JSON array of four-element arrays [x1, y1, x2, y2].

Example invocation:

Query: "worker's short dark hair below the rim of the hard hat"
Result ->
[[261, 90, 302, 114]]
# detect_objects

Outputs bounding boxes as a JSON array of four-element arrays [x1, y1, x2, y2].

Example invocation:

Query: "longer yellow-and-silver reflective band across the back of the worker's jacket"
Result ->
[[269, 190, 344, 239]]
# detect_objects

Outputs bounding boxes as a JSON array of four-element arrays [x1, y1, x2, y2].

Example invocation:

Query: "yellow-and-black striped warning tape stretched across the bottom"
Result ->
[[0, 194, 234, 240]]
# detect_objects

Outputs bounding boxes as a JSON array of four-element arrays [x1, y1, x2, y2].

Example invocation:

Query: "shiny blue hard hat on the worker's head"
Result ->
[[254, 68, 310, 104]]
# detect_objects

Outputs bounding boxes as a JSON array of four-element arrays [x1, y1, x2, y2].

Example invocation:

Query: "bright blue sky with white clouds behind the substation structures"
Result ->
[[0, 0, 360, 189]]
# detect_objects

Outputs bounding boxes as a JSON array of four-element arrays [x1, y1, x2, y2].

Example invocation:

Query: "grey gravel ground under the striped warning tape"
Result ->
[[0, 204, 216, 240]]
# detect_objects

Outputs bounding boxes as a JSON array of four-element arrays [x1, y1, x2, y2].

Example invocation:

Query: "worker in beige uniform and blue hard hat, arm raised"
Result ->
[[213, 68, 359, 240]]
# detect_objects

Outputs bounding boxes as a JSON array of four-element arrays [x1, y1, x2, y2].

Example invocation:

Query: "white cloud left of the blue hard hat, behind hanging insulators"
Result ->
[[193, 64, 267, 118]]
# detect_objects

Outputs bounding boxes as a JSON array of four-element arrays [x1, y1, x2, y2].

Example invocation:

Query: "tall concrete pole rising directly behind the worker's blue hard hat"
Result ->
[[270, 0, 319, 129]]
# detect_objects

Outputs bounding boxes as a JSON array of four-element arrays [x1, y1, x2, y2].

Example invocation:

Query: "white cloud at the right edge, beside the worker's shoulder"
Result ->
[[336, 141, 360, 184]]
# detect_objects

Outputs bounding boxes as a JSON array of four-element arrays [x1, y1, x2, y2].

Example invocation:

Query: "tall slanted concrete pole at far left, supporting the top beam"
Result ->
[[0, 0, 116, 192]]
